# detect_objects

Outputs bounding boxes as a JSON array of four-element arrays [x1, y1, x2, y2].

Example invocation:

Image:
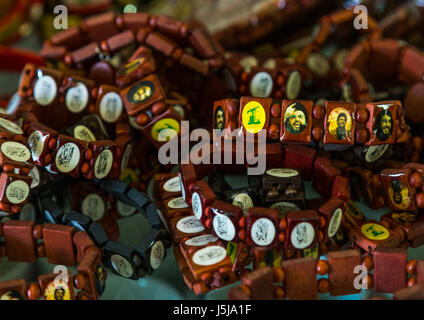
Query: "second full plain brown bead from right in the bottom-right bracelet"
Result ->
[[328, 250, 362, 296]]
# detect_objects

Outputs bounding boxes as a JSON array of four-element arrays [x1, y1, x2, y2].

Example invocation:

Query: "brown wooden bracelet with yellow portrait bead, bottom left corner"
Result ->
[[0, 220, 106, 300]]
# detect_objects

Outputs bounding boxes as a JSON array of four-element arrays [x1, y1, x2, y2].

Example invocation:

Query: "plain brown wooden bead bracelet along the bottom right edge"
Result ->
[[228, 248, 424, 300]]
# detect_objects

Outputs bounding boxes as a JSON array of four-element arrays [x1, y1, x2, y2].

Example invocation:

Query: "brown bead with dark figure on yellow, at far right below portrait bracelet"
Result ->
[[379, 169, 417, 211]]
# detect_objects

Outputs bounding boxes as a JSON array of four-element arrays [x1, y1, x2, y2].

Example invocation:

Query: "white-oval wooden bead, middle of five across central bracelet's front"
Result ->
[[246, 207, 280, 248]]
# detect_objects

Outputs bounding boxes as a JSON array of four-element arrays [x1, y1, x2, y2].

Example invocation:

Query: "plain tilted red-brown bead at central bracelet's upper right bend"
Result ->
[[312, 157, 341, 198]]
